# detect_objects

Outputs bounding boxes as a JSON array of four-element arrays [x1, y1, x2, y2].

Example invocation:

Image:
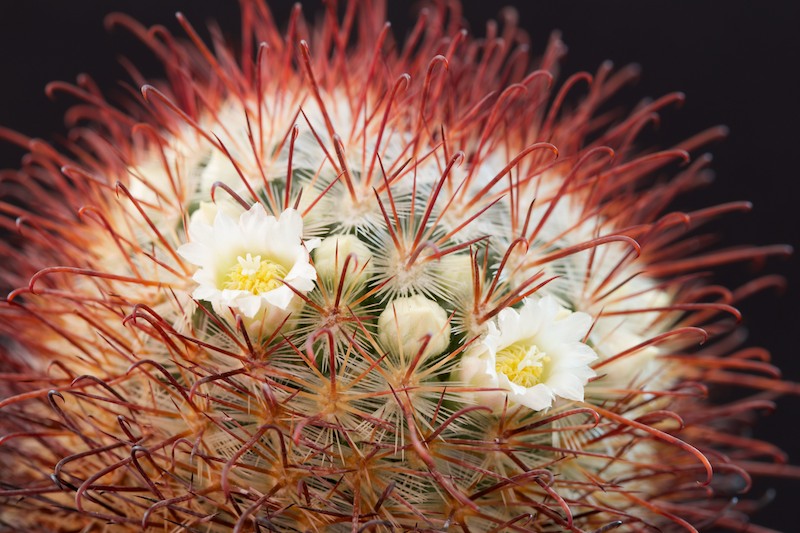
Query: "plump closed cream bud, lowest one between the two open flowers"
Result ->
[[378, 294, 450, 358]]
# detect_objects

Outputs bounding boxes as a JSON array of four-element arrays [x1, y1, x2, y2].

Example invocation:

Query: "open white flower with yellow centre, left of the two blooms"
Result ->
[[178, 204, 317, 334]]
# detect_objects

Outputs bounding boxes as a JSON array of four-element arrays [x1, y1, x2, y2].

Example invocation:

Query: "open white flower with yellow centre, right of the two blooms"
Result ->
[[456, 296, 597, 411]]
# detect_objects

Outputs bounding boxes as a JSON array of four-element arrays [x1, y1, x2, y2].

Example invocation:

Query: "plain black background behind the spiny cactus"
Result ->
[[0, 0, 800, 532]]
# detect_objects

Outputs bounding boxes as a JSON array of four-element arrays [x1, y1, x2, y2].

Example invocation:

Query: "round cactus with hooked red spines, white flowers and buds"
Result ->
[[0, 0, 796, 532]]
